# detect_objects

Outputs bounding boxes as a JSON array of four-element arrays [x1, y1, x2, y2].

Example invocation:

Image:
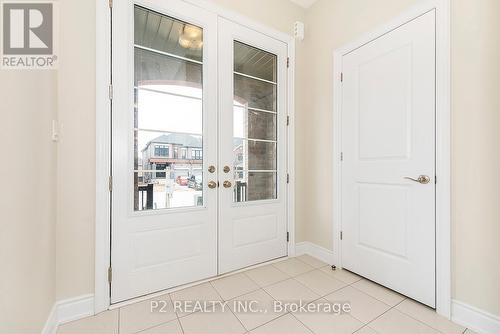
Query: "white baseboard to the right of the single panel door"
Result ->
[[451, 300, 500, 334]]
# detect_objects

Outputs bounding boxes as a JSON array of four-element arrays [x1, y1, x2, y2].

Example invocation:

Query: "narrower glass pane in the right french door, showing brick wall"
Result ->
[[233, 41, 277, 202]]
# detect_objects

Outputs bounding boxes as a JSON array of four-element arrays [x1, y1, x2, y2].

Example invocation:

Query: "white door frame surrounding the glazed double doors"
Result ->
[[94, 0, 295, 314]]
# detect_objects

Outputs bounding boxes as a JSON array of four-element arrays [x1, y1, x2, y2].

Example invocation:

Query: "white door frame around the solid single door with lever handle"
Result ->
[[332, 0, 451, 319]]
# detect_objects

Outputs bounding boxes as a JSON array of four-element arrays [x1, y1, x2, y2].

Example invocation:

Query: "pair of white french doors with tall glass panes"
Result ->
[[111, 0, 287, 303]]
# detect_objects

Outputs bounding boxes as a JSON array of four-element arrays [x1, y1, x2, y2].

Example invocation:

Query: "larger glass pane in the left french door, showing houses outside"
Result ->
[[133, 6, 203, 211]]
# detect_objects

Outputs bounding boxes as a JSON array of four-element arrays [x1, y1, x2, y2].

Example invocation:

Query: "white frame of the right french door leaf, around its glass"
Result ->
[[219, 18, 287, 273]]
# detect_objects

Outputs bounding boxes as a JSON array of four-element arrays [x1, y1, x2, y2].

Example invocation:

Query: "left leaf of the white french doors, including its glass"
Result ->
[[111, 0, 217, 303]]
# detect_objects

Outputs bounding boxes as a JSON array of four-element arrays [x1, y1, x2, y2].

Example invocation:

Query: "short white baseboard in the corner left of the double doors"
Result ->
[[42, 294, 94, 334]]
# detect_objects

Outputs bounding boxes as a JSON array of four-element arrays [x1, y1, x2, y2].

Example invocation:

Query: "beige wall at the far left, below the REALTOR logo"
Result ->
[[0, 69, 56, 334]]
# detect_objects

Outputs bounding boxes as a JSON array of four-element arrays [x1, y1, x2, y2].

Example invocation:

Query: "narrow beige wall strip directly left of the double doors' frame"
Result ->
[[56, 0, 95, 300]]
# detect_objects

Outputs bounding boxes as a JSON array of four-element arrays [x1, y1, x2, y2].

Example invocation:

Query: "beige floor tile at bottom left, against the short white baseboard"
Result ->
[[57, 310, 118, 334]]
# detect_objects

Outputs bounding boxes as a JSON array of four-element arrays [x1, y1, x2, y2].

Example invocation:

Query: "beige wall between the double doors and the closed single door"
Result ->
[[295, 0, 416, 249]]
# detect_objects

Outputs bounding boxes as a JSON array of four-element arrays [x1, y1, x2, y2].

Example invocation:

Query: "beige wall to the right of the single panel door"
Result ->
[[452, 0, 500, 315]]
